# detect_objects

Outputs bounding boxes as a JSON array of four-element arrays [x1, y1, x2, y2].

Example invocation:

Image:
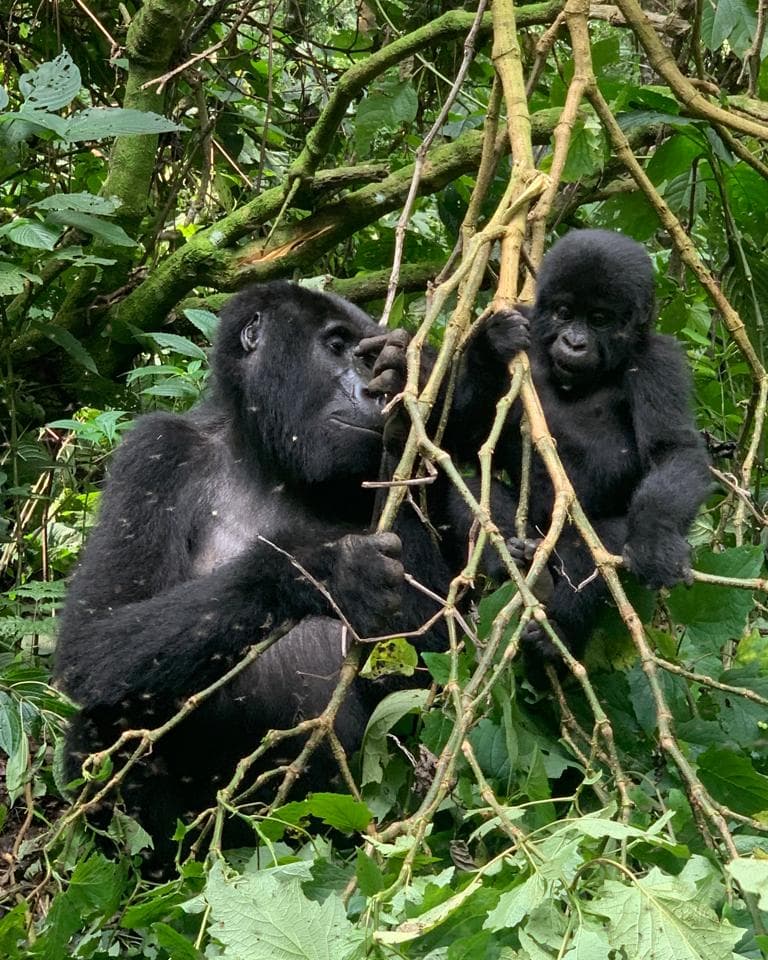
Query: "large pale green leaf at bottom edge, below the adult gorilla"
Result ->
[[205, 868, 364, 960]]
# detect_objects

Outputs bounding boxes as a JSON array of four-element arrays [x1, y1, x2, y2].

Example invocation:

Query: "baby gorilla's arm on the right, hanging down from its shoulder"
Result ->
[[624, 334, 710, 588]]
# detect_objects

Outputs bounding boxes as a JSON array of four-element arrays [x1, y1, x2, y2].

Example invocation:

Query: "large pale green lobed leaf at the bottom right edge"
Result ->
[[584, 867, 744, 960]]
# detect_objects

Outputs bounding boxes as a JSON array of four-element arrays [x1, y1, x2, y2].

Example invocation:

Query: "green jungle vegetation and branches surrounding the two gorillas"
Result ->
[[0, 0, 768, 960]]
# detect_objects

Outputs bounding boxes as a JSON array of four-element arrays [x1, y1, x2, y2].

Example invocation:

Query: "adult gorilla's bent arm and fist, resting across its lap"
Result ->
[[56, 415, 402, 713]]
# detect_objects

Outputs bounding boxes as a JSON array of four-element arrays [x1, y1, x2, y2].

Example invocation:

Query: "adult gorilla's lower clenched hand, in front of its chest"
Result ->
[[328, 533, 404, 637]]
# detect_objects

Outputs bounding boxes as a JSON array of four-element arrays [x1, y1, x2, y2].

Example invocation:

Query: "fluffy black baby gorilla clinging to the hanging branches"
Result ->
[[450, 230, 709, 672]]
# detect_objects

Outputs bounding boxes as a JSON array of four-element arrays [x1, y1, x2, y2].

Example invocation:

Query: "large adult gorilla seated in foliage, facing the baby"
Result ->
[[56, 282, 480, 860]]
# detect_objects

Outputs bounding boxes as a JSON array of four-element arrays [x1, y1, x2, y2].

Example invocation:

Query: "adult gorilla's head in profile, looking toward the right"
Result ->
[[214, 281, 384, 484]]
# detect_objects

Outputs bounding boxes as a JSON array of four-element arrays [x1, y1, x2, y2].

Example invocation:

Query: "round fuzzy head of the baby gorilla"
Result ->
[[532, 230, 654, 389]]
